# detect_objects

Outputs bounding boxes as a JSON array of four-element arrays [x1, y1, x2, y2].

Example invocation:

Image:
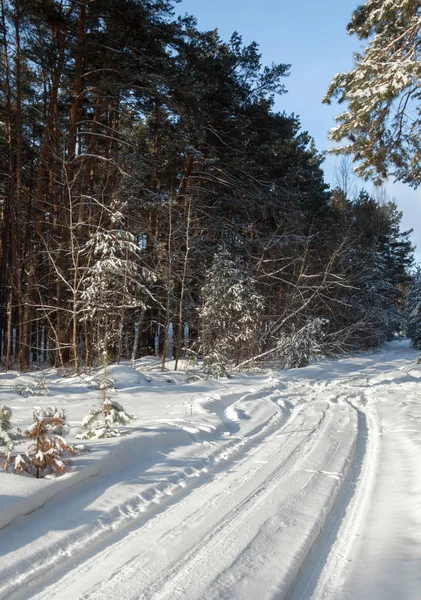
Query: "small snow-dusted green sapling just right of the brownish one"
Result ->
[[76, 351, 134, 439]]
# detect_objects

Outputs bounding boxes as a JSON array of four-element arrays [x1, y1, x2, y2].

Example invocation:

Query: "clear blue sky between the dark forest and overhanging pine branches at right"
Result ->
[[177, 0, 421, 261]]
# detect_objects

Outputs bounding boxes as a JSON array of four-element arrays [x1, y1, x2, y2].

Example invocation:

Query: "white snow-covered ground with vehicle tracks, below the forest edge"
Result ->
[[0, 342, 421, 600]]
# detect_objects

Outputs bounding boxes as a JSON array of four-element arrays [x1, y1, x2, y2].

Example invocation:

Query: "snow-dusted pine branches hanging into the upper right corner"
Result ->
[[324, 0, 421, 186]]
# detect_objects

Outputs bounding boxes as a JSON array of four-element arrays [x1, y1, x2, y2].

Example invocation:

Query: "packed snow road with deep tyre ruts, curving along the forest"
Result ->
[[0, 342, 421, 600]]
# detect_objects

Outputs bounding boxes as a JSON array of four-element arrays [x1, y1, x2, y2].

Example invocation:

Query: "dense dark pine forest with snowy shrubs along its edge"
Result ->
[[0, 0, 413, 376]]
